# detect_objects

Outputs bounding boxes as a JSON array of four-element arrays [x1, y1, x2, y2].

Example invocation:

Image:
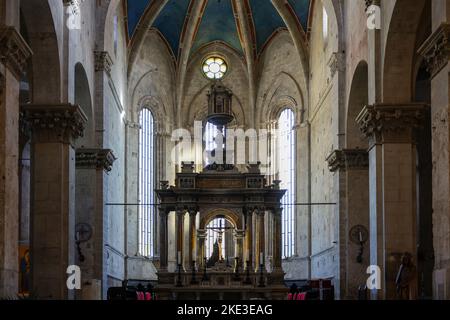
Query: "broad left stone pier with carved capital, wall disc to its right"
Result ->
[[22, 104, 87, 299]]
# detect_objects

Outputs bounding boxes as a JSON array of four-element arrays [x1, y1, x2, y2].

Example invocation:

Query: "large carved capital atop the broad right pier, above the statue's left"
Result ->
[[356, 103, 429, 143]]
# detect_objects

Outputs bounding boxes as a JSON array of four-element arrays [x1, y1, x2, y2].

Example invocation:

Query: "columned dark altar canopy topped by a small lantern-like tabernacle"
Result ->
[[155, 85, 288, 300]]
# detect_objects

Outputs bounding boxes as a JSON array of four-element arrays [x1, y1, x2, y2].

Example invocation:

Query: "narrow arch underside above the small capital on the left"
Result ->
[[74, 62, 95, 148]]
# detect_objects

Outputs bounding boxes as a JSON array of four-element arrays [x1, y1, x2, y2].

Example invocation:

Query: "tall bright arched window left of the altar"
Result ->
[[139, 109, 155, 257]]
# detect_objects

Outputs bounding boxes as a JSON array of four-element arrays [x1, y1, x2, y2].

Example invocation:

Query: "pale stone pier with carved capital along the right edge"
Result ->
[[419, 21, 450, 300]]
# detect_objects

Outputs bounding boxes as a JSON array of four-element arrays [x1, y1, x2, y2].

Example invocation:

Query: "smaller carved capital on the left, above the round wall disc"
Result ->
[[76, 149, 117, 172]]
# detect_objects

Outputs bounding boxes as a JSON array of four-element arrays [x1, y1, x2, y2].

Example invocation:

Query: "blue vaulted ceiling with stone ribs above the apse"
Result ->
[[126, 0, 311, 59]]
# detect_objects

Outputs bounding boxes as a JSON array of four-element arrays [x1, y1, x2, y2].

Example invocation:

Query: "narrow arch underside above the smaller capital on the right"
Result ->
[[346, 61, 369, 149]]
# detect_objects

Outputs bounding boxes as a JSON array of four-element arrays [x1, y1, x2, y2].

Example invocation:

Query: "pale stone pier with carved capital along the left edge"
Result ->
[[0, 25, 31, 297]]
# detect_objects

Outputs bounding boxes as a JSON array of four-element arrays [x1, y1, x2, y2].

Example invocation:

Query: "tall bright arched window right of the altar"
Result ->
[[278, 109, 296, 258]]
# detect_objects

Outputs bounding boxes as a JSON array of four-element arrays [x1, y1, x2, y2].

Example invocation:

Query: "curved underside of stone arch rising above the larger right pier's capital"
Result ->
[[383, 0, 427, 103]]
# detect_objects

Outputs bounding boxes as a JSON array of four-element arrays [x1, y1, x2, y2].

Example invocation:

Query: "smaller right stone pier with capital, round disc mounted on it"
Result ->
[[327, 149, 370, 299]]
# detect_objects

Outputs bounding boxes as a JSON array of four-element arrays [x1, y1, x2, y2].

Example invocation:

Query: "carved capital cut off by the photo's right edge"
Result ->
[[418, 23, 450, 78]]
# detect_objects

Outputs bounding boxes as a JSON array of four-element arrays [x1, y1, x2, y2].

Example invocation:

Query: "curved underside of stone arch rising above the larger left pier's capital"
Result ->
[[20, 0, 62, 104]]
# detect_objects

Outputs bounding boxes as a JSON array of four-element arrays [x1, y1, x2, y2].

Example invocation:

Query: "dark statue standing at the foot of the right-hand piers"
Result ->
[[395, 252, 417, 300]]
